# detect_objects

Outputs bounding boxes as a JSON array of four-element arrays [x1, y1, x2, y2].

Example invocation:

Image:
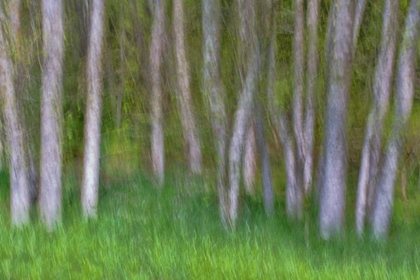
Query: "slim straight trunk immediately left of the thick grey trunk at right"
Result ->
[[303, 0, 319, 194]]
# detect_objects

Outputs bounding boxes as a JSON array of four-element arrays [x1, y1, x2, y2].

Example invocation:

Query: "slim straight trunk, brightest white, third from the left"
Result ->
[[82, 0, 105, 218]]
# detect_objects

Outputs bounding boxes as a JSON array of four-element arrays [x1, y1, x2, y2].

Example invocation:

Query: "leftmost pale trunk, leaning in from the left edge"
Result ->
[[0, 13, 30, 226]]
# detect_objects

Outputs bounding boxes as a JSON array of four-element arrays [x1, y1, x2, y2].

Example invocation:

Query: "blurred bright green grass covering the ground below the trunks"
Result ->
[[0, 170, 420, 280]]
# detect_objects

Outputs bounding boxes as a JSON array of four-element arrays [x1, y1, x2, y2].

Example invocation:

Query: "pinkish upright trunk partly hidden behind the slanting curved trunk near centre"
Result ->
[[236, 0, 257, 194]]
